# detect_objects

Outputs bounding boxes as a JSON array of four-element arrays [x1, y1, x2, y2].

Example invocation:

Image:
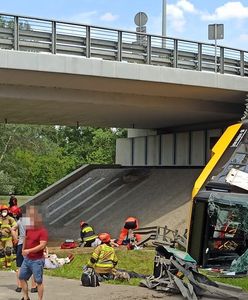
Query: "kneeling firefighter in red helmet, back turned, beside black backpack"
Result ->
[[87, 233, 118, 281]]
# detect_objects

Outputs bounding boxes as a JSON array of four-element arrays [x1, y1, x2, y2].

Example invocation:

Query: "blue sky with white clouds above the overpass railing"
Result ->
[[0, 0, 248, 50]]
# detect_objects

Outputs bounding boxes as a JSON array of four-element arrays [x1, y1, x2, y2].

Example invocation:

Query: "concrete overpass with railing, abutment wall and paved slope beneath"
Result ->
[[0, 14, 248, 238]]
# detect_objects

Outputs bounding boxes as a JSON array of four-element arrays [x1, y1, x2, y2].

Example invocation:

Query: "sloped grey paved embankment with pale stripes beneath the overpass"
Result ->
[[26, 166, 200, 240]]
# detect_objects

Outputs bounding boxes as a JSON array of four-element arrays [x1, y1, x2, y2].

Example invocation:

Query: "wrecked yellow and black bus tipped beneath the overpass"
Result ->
[[188, 121, 248, 267]]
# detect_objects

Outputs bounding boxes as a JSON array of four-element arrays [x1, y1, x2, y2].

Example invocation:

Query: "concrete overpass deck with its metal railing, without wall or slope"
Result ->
[[0, 14, 248, 129]]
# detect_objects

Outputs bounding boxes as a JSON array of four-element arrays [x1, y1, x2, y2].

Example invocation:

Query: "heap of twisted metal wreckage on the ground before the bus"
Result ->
[[141, 245, 244, 300]]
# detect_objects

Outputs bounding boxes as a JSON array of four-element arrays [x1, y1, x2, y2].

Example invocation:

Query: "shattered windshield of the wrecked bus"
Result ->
[[208, 192, 248, 260]]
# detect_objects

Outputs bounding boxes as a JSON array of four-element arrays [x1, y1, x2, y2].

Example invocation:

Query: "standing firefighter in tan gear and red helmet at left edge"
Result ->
[[0, 205, 17, 268]]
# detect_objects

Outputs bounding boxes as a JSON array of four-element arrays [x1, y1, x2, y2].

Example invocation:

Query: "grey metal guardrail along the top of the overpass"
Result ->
[[0, 13, 248, 76]]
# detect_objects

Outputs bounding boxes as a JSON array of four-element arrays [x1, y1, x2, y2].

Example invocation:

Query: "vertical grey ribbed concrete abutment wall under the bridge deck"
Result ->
[[116, 129, 222, 166]]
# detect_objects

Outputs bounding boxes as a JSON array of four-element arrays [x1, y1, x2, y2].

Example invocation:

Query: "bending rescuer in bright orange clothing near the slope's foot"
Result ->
[[117, 217, 141, 249]]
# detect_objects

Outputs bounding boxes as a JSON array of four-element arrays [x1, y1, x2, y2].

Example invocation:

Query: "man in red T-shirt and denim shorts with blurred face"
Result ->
[[19, 206, 48, 300]]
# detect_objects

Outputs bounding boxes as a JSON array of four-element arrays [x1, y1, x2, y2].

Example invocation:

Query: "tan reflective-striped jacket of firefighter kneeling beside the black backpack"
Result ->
[[88, 244, 118, 274]]
